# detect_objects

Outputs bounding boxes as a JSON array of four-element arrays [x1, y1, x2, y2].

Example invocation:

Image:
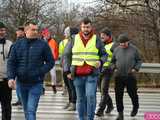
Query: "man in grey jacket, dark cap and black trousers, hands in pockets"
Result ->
[[112, 33, 142, 120]]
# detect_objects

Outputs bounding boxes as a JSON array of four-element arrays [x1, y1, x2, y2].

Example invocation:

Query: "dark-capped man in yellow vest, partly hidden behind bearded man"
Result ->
[[96, 27, 114, 117]]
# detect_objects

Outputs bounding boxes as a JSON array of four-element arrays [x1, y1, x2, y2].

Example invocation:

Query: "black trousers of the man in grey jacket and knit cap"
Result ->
[[115, 74, 139, 112]]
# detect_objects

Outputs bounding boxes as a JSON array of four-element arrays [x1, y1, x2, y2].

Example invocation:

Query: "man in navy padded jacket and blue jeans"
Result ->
[[7, 22, 54, 120]]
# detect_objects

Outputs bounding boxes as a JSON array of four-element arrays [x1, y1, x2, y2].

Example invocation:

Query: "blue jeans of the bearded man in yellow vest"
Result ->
[[74, 75, 98, 120]]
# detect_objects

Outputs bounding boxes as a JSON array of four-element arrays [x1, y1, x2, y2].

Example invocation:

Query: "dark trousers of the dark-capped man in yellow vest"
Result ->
[[98, 70, 113, 111]]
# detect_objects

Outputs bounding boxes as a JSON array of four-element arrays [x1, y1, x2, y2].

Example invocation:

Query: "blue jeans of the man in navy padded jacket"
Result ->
[[17, 82, 43, 120]]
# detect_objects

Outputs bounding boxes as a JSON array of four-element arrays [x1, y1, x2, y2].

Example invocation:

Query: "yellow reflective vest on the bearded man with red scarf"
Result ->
[[72, 34, 99, 66]]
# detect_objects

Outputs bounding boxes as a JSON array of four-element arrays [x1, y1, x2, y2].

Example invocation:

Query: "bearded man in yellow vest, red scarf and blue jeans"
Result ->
[[64, 18, 107, 120]]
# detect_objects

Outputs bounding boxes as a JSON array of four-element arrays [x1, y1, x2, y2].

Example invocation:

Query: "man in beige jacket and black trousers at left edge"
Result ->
[[0, 22, 12, 120]]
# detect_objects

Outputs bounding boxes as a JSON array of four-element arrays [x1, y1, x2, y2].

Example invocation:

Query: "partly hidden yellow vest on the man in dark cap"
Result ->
[[103, 42, 113, 67]]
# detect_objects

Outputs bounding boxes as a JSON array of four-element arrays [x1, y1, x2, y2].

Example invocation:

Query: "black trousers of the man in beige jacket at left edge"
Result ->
[[0, 80, 12, 120]]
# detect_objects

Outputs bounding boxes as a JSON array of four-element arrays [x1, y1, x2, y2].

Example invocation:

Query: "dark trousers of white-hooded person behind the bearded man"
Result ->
[[63, 74, 77, 103]]
